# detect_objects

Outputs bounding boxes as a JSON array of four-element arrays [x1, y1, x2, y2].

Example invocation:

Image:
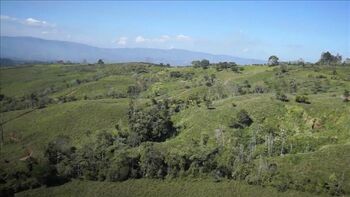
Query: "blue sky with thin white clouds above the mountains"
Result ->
[[1, 1, 350, 61]]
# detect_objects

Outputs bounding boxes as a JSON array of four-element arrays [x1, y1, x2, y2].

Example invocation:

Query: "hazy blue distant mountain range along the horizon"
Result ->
[[0, 36, 265, 65]]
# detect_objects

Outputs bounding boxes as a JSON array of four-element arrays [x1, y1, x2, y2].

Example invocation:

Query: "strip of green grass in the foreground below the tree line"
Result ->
[[16, 179, 313, 197]]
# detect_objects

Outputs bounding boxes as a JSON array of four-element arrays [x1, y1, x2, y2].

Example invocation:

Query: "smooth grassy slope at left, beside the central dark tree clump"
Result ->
[[0, 99, 128, 172]]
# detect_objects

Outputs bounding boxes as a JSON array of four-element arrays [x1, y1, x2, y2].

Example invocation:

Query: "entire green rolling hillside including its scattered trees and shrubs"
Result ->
[[0, 63, 350, 196]]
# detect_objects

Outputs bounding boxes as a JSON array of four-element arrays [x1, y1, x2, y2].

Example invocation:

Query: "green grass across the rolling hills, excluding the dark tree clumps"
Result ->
[[0, 63, 350, 196]]
